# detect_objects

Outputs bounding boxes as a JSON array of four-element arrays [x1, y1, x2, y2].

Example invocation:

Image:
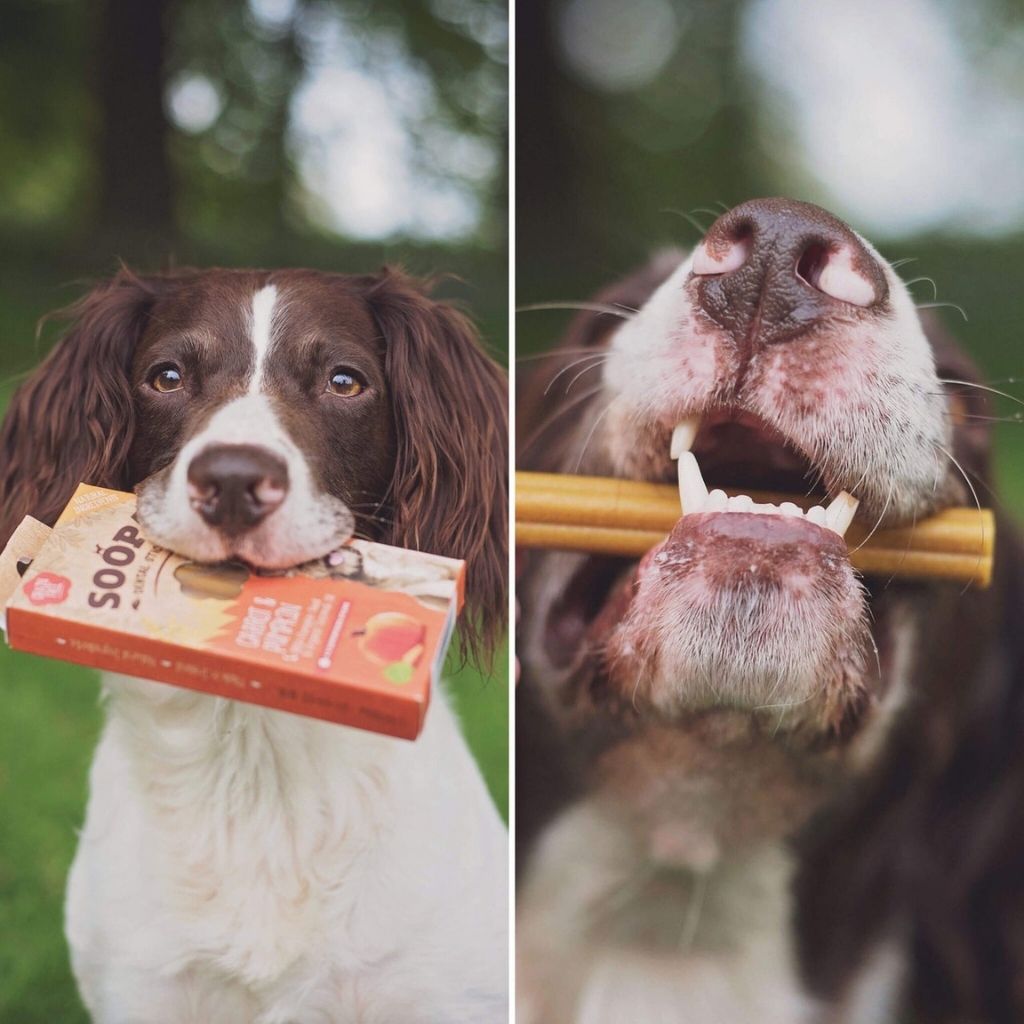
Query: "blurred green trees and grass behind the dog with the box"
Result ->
[[0, 0, 508, 1024]]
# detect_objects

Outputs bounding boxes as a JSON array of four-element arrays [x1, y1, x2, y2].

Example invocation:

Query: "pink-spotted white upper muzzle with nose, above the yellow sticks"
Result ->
[[598, 199, 950, 524]]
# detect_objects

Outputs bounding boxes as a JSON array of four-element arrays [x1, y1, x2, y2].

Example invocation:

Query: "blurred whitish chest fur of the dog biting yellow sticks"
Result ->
[[517, 801, 812, 1024]]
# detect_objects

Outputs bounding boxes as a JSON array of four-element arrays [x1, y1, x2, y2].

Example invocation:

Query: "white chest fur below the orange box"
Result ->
[[67, 676, 507, 1024]]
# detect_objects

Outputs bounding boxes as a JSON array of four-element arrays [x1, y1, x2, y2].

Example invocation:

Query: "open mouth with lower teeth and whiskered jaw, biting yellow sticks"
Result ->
[[547, 409, 871, 728]]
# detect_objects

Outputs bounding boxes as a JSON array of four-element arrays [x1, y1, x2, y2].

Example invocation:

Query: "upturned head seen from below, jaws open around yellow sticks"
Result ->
[[520, 200, 987, 738]]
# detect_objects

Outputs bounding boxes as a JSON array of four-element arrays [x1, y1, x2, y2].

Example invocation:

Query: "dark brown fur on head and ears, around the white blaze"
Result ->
[[0, 268, 508, 654]]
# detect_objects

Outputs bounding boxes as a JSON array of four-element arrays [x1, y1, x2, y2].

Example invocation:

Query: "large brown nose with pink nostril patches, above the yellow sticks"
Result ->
[[692, 199, 889, 346]]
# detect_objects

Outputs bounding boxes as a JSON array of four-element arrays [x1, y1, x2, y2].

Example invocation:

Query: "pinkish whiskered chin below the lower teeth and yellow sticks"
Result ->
[[591, 512, 871, 731]]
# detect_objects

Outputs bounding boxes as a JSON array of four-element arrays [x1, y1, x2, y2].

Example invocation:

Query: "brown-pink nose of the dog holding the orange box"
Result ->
[[187, 444, 288, 536]]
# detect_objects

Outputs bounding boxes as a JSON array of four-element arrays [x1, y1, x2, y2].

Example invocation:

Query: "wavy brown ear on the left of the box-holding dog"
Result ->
[[0, 269, 155, 546]]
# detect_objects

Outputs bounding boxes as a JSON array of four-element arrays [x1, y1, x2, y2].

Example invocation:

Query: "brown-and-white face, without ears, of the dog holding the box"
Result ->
[[132, 274, 393, 568]]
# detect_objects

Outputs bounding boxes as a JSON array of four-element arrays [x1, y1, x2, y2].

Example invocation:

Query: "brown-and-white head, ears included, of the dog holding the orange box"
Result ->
[[0, 270, 507, 655]]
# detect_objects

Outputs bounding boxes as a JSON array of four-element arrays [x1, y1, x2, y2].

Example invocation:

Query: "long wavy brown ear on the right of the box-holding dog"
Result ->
[[367, 270, 508, 656]]
